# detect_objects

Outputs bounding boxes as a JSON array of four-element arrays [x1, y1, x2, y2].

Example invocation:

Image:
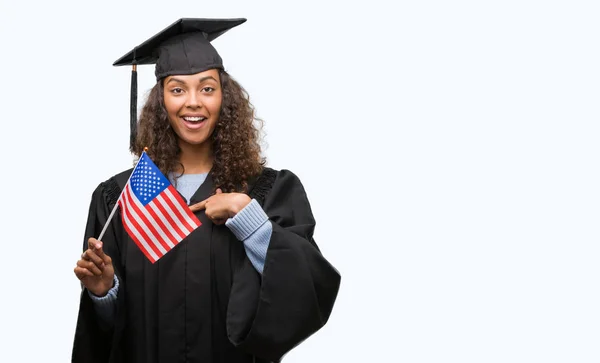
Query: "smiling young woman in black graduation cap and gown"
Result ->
[[73, 19, 340, 363]]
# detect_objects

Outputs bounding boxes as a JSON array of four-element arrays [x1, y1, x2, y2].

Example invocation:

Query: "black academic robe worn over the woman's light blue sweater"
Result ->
[[72, 168, 340, 363]]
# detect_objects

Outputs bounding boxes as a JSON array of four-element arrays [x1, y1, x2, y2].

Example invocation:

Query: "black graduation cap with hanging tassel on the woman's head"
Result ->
[[113, 18, 246, 150]]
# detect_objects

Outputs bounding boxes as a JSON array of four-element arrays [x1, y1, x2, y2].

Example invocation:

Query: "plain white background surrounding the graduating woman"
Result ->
[[0, 0, 600, 363]]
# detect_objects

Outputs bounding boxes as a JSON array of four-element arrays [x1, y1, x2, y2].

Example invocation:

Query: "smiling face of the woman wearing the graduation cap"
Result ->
[[163, 69, 223, 148]]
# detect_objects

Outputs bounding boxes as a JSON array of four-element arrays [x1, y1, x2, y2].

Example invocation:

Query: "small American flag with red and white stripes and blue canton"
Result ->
[[118, 151, 201, 263]]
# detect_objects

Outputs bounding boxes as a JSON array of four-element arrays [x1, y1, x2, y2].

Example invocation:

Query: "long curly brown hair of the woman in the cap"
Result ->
[[131, 70, 266, 192]]
